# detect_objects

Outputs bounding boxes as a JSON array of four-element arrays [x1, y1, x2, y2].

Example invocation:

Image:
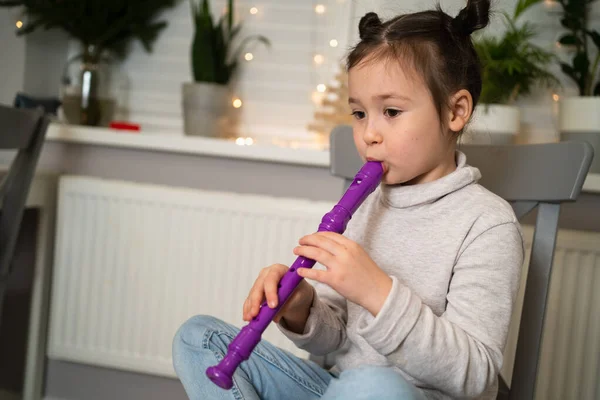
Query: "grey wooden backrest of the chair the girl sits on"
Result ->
[[330, 125, 594, 399]]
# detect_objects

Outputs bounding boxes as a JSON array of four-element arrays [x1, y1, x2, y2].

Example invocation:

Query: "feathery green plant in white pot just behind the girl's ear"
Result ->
[[467, 0, 558, 144]]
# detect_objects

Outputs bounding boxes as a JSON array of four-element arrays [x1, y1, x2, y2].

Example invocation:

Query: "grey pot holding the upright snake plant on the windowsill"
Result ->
[[181, 82, 231, 137]]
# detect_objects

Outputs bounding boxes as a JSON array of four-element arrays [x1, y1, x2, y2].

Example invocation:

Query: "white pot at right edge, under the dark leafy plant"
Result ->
[[558, 97, 600, 173]]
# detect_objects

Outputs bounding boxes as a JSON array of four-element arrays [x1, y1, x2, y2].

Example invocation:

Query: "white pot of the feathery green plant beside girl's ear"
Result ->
[[461, 104, 521, 144]]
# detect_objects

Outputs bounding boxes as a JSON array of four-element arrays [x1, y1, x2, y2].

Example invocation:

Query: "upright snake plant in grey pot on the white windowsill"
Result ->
[[182, 0, 270, 136]]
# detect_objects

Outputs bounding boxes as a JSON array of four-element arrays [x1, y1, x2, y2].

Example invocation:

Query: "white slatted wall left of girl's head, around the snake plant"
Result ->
[[96, 0, 351, 142]]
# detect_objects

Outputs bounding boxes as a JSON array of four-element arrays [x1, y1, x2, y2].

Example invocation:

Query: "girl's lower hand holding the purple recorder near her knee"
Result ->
[[243, 264, 314, 330]]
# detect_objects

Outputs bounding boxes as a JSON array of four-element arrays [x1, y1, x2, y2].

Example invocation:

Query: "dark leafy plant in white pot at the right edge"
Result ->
[[558, 0, 600, 173]]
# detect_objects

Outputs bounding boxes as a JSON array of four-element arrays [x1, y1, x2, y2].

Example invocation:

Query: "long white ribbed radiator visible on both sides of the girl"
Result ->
[[49, 177, 600, 400]]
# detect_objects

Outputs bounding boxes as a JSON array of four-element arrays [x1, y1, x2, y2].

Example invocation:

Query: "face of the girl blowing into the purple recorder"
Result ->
[[348, 61, 456, 185]]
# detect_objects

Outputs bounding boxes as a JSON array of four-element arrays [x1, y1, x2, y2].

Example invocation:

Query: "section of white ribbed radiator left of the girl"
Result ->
[[49, 177, 333, 376]]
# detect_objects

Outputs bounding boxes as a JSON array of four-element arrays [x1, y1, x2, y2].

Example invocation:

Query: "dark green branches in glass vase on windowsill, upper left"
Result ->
[[0, 0, 178, 125]]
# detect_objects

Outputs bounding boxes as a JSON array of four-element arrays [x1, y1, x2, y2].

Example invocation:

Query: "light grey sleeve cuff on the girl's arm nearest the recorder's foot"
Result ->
[[277, 276, 348, 355]]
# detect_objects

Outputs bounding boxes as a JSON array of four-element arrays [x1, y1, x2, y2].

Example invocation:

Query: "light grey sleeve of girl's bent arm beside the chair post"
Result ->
[[358, 222, 524, 398]]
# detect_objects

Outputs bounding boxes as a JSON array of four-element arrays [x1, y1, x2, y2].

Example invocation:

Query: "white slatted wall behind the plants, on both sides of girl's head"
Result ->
[[52, 0, 600, 142]]
